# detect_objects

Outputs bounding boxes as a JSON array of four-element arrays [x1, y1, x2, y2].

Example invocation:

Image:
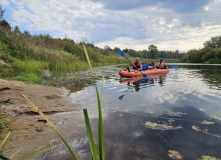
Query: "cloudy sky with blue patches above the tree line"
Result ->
[[0, 0, 221, 52]]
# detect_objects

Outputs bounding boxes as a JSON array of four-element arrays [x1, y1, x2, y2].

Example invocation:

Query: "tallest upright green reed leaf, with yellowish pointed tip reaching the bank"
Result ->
[[83, 44, 105, 160]]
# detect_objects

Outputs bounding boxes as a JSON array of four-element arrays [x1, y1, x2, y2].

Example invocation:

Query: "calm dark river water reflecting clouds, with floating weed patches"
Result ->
[[40, 64, 221, 160]]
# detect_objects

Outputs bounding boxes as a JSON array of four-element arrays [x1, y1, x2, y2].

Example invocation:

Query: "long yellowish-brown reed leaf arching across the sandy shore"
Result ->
[[10, 88, 78, 160]]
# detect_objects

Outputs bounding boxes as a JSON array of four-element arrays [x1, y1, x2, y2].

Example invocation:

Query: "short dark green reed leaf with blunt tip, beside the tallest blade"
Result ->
[[83, 109, 98, 160]]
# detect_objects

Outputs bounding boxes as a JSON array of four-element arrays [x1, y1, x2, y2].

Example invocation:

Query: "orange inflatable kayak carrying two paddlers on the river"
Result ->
[[119, 68, 169, 77]]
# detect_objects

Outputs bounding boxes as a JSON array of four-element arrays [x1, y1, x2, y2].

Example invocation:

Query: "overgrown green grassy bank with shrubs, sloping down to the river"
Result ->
[[0, 27, 181, 83]]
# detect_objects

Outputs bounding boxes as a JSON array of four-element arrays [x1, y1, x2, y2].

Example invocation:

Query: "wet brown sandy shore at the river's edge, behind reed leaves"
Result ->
[[0, 79, 86, 159]]
